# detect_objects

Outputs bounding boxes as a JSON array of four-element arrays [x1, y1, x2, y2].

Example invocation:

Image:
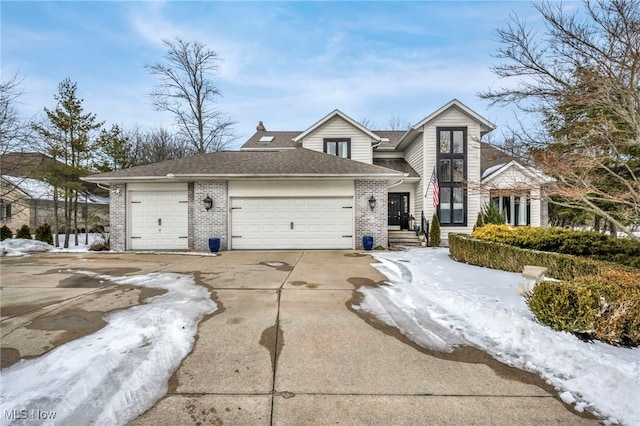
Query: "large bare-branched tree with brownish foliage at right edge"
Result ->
[[480, 0, 640, 239]]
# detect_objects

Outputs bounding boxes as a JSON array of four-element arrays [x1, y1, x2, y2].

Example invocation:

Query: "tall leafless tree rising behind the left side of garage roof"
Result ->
[[145, 37, 236, 154]]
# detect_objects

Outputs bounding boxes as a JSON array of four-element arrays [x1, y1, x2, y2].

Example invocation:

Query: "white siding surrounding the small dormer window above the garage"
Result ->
[[302, 116, 373, 164]]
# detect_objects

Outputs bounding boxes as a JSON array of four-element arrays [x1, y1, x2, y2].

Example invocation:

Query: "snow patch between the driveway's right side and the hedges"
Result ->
[[358, 248, 640, 425]]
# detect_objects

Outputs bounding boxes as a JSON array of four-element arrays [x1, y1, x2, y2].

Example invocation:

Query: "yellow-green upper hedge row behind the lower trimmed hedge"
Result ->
[[471, 224, 640, 268]]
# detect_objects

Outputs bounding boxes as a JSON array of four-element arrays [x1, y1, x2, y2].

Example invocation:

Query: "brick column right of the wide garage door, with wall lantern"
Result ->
[[355, 180, 389, 250]]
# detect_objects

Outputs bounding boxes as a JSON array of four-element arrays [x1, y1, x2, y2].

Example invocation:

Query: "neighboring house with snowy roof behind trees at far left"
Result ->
[[0, 153, 109, 233]]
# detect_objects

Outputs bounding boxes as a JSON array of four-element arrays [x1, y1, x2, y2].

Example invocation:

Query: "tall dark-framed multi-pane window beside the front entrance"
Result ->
[[436, 127, 467, 226]]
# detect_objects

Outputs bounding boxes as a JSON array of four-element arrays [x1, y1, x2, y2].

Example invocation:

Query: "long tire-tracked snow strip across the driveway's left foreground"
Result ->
[[0, 272, 216, 425]]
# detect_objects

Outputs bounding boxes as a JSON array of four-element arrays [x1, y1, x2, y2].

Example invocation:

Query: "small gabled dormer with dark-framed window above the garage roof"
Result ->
[[293, 109, 381, 164]]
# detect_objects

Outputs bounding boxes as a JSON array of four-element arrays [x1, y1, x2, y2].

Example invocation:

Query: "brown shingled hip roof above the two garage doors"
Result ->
[[83, 148, 404, 183]]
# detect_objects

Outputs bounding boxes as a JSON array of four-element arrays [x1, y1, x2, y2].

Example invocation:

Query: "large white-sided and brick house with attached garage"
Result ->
[[84, 99, 544, 251]]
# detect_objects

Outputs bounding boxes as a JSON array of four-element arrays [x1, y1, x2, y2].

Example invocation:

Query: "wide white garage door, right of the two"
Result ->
[[231, 197, 353, 250]]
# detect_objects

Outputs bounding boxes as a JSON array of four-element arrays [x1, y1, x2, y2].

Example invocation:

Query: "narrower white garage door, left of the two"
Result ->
[[130, 191, 189, 250]]
